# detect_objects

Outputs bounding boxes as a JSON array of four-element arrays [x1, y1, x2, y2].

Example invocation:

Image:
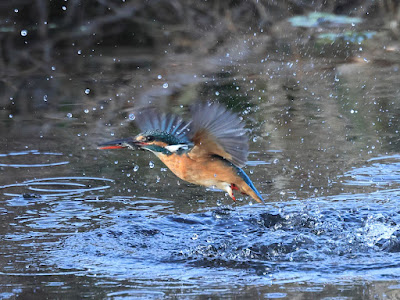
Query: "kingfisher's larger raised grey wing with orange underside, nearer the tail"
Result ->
[[189, 103, 249, 167]]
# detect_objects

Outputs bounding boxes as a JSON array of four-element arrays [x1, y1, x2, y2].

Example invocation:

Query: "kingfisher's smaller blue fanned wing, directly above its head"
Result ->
[[134, 107, 190, 143]]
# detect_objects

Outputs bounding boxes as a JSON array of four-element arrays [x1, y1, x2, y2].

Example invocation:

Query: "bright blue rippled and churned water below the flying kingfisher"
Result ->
[[0, 149, 400, 298]]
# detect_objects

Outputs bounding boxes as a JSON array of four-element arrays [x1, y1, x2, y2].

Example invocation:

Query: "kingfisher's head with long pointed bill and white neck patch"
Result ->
[[99, 130, 193, 155]]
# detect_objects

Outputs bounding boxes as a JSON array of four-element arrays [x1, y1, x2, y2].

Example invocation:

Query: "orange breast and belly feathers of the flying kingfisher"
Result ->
[[158, 154, 243, 186]]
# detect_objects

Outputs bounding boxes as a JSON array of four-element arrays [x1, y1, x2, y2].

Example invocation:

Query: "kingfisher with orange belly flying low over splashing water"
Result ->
[[99, 102, 265, 203]]
